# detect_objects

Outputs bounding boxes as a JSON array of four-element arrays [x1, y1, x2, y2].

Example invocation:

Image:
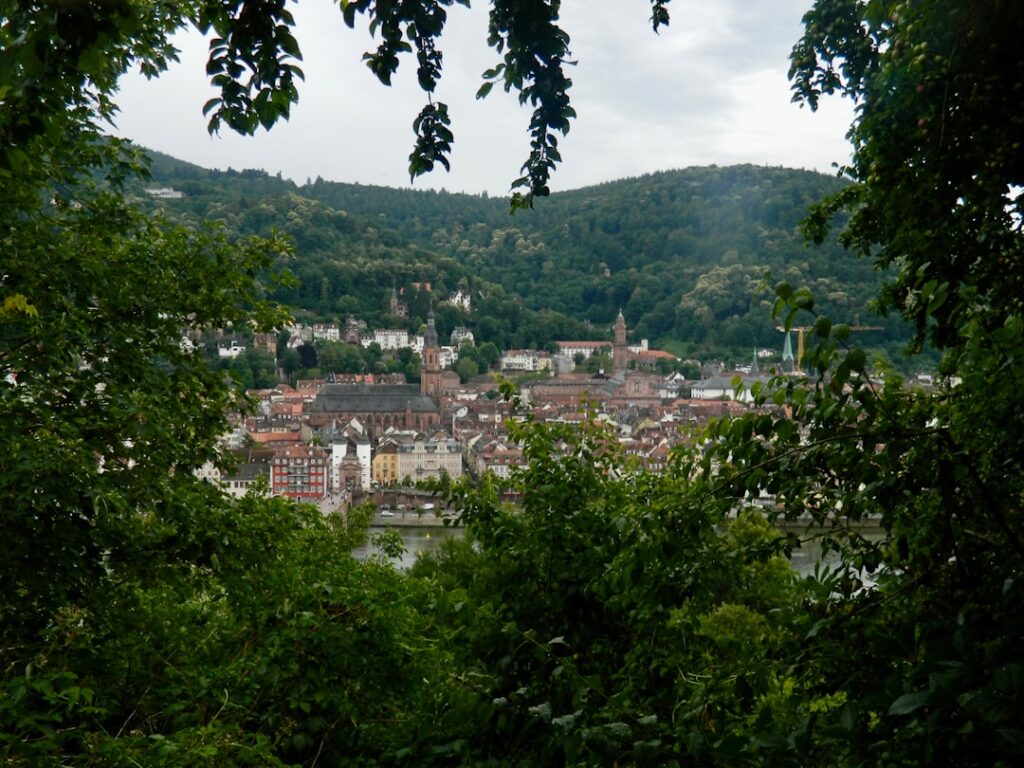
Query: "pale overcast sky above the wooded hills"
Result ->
[[114, 0, 853, 195]]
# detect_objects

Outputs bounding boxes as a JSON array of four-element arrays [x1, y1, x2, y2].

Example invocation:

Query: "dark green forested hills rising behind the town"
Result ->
[[146, 154, 902, 362]]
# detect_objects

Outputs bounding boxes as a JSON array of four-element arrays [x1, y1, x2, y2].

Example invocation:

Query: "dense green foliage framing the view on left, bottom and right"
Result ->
[[0, 0, 1024, 766]]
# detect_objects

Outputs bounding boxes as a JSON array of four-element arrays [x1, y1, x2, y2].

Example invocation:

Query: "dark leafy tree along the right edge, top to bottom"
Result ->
[[688, 0, 1024, 765]]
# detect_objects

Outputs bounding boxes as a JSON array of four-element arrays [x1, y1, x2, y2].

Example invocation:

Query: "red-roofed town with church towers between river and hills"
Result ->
[[196, 292, 799, 512]]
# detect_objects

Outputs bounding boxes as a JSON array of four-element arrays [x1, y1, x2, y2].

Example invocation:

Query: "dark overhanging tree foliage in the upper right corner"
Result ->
[[792, 0, 1024, 347]]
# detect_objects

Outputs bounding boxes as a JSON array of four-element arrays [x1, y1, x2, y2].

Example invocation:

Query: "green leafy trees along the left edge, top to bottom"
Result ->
[[0, 2, 460, 765]]
